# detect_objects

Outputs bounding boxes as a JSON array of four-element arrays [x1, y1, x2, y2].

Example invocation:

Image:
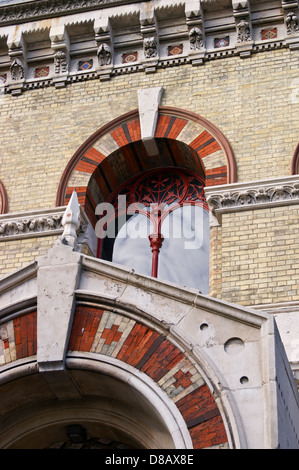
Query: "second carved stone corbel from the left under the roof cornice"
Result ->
[[50, 25, 70, 88]]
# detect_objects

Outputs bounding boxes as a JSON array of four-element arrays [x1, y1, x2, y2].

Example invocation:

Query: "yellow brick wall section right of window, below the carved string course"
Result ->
[[210, 206, 299, 305]]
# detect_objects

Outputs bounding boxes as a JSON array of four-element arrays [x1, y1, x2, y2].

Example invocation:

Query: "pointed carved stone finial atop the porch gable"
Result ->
[[61, 191, 80, 248]]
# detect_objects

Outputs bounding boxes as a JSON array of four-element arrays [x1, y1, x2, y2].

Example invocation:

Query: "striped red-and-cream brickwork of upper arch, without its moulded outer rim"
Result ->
[[65, 113, 228, 224]]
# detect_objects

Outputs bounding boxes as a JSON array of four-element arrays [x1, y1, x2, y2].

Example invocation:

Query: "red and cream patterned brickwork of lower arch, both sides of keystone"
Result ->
[[0, 305, 228, 449]]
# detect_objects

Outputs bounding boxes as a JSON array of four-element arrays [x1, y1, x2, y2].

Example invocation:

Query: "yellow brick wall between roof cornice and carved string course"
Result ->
[[0, 49, 299, 212]]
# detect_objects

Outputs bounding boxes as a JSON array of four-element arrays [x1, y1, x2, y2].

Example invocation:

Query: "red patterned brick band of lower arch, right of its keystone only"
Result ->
[[69, 305, 228, 449]]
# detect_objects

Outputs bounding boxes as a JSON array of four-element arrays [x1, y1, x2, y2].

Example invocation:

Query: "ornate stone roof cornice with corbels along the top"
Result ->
[[0, 0, 299, 95]]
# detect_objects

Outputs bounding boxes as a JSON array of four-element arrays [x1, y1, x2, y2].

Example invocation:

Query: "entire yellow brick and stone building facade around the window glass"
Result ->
[[0, 0, 299, 449]]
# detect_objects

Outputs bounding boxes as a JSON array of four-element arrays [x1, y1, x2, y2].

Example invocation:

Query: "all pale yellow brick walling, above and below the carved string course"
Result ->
[[0, 49, 299, 305]]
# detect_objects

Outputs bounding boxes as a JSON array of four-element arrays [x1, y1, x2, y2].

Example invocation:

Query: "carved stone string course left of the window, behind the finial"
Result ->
[[0, 207, 88, 242]]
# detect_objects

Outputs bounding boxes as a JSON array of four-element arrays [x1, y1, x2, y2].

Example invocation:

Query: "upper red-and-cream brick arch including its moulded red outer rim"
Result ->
[[56, 106, 236, 228]]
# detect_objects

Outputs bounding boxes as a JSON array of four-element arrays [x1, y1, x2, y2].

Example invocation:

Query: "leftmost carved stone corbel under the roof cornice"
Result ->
[[7, 27, 27, 95]]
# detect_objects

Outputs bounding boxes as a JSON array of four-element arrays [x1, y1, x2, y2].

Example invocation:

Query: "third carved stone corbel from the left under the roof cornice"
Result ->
[[94, 15, 114, 81]]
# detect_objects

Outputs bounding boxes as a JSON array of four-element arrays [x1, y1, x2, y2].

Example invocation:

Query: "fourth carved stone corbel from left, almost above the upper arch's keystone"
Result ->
[[139, 9, 160, 73]]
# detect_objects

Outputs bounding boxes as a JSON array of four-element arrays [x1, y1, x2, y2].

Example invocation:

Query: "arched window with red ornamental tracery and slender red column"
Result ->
[[96, 168, 209, 294]]
